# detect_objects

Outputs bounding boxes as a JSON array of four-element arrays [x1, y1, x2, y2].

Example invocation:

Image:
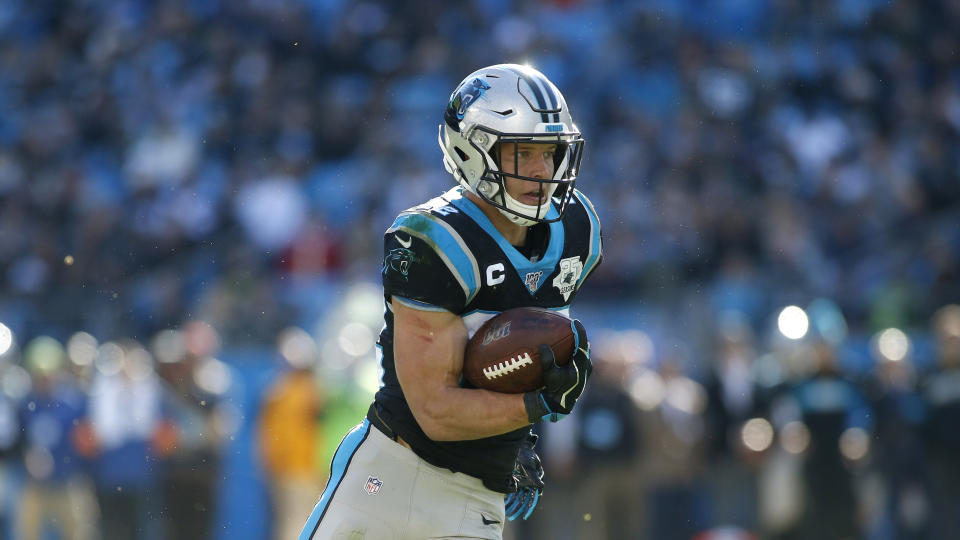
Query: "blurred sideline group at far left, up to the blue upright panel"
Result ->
[[0, 323, 236, 540]]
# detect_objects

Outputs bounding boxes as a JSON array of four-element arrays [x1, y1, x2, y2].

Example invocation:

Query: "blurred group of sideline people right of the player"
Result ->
[[513, 304, 960, 540]]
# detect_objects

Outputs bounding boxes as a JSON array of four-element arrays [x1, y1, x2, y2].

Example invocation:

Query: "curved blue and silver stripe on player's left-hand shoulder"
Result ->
[[387, 212, 481, 305]]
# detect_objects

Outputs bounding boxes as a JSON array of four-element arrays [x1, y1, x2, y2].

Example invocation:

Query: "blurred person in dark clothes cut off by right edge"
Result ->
[[921, 304, 960, 540]]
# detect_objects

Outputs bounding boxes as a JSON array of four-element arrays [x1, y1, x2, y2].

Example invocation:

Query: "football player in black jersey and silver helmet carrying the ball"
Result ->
[[300, 64, 602, 540]]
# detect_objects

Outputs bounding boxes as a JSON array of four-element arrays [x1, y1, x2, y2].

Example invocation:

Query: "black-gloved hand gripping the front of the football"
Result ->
[[523, 319, 593, 424]]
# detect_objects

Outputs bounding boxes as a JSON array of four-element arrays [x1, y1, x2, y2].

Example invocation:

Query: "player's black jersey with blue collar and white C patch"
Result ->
[[370, 187, 603, 492]]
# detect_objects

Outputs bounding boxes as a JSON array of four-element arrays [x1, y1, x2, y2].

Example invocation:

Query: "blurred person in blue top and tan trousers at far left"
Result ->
[[17, 336, 99, 540]]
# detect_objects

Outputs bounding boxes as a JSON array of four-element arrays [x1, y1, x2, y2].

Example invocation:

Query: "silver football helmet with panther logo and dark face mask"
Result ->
[[438, 64, 583, 226]]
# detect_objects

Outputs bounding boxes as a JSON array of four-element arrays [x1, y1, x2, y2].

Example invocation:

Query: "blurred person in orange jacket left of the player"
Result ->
[[258, 329, 328, 540]]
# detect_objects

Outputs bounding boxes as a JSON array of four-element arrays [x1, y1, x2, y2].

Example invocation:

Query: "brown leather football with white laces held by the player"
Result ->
[[463, 308, 576, 394]]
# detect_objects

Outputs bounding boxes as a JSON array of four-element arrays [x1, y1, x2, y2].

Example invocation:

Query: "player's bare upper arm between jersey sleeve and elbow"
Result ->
[[392, 296, 467, 425]]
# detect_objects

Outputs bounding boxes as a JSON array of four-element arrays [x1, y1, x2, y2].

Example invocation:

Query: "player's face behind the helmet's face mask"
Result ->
[[500, 143, 557, 206]]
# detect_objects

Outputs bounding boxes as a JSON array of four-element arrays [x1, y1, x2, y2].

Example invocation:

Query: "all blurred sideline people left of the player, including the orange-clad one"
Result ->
[[0, 321, 376, 540]]
